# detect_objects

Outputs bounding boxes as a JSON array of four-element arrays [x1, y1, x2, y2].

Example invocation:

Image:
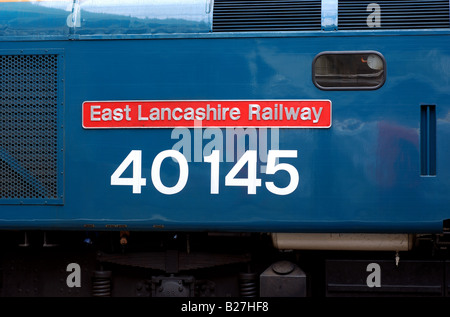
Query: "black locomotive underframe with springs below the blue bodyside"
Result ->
[[0, 231, 450, 298]]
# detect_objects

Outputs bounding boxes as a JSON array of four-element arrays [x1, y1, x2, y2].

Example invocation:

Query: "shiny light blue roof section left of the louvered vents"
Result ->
[[0, 0, 212, 39]]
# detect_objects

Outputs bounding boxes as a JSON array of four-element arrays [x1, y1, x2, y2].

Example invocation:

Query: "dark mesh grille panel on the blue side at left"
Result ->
[[0, 55, 58, 199]]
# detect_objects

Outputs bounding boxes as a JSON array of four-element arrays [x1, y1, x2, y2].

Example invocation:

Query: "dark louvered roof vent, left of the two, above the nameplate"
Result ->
[[213, 0, 321, 32]]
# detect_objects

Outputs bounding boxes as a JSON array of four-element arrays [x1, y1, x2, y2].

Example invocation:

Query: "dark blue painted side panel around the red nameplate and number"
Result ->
[[0, 0, 450, 232]]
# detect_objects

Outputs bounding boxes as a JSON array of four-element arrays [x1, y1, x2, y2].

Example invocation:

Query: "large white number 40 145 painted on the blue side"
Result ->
[[111, 150, 299, 195]]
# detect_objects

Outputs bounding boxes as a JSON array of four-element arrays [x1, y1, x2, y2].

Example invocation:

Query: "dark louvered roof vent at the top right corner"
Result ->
[[338, 0, 450, 30]]
